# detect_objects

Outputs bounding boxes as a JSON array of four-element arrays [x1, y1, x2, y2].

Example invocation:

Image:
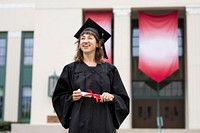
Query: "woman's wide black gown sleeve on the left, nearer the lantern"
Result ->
[[52, 66, 73, 129]]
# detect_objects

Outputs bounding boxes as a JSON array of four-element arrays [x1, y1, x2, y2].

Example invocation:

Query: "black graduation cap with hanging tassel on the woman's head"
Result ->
[[74, 18, 111, 59]]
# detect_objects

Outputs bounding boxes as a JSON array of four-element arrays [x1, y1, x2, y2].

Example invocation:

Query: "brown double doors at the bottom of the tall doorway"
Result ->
[[132, 99, 185, 128]]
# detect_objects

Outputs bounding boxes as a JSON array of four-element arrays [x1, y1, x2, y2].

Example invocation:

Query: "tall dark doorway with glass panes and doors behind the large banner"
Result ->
[[131, 18, 185, 128]]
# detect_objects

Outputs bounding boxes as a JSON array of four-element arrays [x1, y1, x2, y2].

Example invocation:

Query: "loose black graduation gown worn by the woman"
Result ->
[[52, 62, 129, 133]]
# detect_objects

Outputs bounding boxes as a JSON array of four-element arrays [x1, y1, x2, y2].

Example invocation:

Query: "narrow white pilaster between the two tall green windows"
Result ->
[[4, 31, 21, 121]]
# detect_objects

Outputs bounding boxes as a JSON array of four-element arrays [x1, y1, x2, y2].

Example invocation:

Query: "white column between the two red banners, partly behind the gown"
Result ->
[[113, 8, 132, 128]]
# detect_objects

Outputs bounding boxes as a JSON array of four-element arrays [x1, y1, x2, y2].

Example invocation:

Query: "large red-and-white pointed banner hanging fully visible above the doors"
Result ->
[[139, 11, 179, 82]]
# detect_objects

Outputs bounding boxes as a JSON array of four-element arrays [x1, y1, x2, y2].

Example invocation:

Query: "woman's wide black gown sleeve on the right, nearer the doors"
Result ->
[[111, 67, 129, 129]]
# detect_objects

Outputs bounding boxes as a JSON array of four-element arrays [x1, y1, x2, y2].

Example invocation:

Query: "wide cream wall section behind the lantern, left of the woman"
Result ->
[[30, 8, 82, 125]]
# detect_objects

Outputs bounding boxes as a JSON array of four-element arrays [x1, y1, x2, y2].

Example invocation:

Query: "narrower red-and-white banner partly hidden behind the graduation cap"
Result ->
[[85, 11, 112, 63]]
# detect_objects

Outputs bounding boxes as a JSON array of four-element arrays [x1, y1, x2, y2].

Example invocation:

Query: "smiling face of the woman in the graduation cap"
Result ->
[[79, 34, 98, 55]]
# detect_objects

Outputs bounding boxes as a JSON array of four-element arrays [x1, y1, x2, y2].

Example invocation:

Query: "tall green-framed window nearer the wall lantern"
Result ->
[[18, 32, 33, 123]]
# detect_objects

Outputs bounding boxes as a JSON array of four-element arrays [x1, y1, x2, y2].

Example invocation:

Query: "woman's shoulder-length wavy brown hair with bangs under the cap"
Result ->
[[74, 31, 104, 64]]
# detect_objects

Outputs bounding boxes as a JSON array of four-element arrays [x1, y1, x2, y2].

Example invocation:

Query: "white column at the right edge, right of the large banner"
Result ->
[[185, 7, 200, 129]]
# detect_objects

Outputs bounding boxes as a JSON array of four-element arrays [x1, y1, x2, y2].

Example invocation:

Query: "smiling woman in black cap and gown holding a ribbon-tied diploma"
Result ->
[[52, 18, 129, 133]]
